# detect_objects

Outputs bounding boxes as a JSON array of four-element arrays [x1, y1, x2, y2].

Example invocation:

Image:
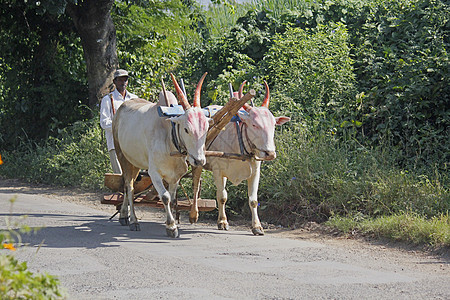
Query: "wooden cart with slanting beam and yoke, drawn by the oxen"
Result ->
[[101, 84, 256, 221]]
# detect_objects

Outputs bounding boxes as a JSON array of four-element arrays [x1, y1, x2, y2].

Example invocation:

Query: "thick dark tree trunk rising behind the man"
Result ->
[[66, 0, 118, 108]]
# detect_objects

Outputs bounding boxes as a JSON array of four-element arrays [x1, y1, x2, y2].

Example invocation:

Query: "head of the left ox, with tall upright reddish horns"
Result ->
[[170, 73, 210, 166]]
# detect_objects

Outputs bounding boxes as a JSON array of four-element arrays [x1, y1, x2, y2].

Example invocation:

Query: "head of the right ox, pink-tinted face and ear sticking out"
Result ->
[[238, 81, 291, 160]]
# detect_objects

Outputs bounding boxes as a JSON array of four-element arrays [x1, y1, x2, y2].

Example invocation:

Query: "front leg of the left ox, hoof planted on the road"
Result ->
[[148, 167, 180, 238]]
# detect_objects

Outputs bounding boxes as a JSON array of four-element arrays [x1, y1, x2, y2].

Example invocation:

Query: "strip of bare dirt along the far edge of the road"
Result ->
[[0, 177, 450, 276]]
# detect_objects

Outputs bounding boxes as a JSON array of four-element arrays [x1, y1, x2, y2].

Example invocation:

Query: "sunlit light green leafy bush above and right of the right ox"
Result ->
[[264, 24, 355, 126]]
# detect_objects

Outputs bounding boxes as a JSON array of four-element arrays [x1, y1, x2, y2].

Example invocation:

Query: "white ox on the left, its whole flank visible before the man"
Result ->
[[112, 73, 209, 237]]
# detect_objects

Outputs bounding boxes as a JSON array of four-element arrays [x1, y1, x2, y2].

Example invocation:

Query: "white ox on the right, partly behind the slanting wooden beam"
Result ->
[[189, 81, 290, 235]]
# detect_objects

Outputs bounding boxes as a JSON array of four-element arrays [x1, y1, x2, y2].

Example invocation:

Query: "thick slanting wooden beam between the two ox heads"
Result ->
[[205, 89, 256, 149]]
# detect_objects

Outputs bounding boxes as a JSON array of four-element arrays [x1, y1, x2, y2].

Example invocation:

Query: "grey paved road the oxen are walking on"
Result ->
[[0, 187, 450, 300]]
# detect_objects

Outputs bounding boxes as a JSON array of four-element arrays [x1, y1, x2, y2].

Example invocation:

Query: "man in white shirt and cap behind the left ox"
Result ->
[[100, 69, 138, 174]]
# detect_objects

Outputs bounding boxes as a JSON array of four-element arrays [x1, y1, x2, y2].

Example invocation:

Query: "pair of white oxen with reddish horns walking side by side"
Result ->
[[112, 73, 290, 237]]
